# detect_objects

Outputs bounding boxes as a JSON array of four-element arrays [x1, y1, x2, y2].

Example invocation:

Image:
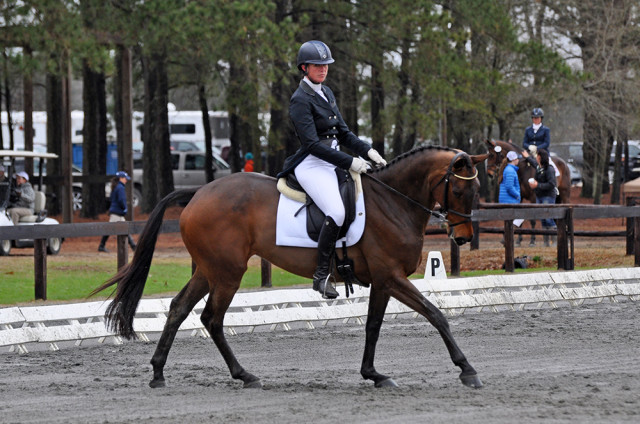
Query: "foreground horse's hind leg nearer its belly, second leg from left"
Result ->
[[200, 280, 262, 388]]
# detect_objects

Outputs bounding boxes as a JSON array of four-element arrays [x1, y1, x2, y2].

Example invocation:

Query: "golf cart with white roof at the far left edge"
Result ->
[[0, 150, 63, 256]]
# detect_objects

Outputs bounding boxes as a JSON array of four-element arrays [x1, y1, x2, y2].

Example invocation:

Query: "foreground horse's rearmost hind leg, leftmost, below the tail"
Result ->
[[149, 269, 209, 387]]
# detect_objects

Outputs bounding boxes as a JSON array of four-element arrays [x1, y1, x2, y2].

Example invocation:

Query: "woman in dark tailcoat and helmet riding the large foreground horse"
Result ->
[[278, 40, 387, 299]]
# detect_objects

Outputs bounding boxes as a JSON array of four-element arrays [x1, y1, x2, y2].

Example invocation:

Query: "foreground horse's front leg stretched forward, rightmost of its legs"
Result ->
[[389, 278, 482, 388]]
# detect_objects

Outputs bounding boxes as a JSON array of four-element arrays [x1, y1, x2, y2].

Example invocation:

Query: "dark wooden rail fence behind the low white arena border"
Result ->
[[0, 203, 640, 300]]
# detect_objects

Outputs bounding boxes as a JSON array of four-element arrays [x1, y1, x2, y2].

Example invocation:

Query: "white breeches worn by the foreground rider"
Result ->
[[294, 151, 345, 227]]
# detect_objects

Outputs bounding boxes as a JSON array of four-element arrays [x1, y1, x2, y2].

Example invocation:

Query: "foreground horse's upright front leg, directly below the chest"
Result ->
[[360, 286, 398, 387]]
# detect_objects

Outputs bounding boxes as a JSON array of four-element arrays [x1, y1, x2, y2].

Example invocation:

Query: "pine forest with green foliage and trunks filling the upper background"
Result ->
[[0, 0, 640, 216]]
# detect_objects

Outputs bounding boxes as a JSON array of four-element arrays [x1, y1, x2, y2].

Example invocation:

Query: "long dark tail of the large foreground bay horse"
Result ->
[[89, 188, 198, 339]]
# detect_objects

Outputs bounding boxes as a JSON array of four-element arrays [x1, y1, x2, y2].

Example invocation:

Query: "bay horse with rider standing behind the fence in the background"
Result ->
[[485, 140, 571, 245]]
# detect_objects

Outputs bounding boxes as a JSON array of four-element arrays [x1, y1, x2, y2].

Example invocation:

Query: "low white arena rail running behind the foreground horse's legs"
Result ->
[[0, 268, 640, 353]]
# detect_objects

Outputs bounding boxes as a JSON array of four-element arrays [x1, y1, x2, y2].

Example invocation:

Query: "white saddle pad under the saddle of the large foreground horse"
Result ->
[[276, 193, 366, 248]]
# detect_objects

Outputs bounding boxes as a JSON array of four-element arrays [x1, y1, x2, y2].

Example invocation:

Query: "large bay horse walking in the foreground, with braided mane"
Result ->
[[92, 146, 487, 388]]
